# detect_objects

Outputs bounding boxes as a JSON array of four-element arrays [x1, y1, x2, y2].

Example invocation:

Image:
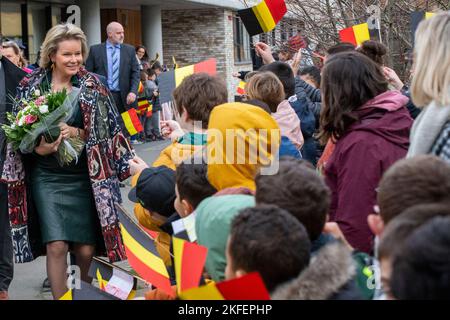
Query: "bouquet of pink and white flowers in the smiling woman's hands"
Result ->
[[2, 88, 85, 166]]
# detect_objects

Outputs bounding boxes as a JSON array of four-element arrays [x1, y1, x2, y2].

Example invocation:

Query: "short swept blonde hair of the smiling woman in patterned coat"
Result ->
[[39, 23, 88, 69]]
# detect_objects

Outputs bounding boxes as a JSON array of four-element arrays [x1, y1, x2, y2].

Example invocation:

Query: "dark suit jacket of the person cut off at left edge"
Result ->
[[0, 57, 26, 172]]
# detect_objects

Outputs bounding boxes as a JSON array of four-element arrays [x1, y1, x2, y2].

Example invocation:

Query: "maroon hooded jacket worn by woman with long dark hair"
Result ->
[[325, 91, 412, 253]]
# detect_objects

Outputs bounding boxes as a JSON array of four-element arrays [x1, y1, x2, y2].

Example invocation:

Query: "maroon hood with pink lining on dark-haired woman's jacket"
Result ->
[[346, 91, 413, 149]]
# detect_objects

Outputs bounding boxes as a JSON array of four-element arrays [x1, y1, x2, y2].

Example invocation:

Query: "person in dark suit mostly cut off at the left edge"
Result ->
[[0, 34, 26, 300]]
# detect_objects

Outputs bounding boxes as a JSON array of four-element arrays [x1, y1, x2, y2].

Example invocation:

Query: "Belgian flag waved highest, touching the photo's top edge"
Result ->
[[238, 0, 287, 36]]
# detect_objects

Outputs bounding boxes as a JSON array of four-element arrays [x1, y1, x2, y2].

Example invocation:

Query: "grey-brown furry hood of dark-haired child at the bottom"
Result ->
[[271, 242, 362, 300]]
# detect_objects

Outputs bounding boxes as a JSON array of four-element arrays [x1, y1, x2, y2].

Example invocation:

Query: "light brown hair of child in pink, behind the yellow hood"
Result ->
[[245, 71, 285, 113]]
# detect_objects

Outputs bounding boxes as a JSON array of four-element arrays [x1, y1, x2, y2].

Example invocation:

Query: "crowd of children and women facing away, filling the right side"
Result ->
[[125, 12, 450, 300]]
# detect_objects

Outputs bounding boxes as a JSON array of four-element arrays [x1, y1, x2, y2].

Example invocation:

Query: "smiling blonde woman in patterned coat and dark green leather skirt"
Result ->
[[2, 24, 133, 299]]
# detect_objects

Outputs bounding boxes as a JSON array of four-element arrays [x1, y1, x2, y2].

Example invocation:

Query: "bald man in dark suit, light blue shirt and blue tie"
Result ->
[[86, 22, 140, 113]]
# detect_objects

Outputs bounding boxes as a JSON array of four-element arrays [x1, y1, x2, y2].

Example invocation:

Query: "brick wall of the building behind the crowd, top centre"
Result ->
[[162, 8, 252, 101]]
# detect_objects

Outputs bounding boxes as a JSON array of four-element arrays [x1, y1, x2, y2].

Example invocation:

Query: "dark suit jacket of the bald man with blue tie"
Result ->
[[86, 42, 140, 108]]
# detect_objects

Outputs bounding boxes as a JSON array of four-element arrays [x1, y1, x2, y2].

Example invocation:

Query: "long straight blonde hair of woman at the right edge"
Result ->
[[411, 12, 450, 107]]
